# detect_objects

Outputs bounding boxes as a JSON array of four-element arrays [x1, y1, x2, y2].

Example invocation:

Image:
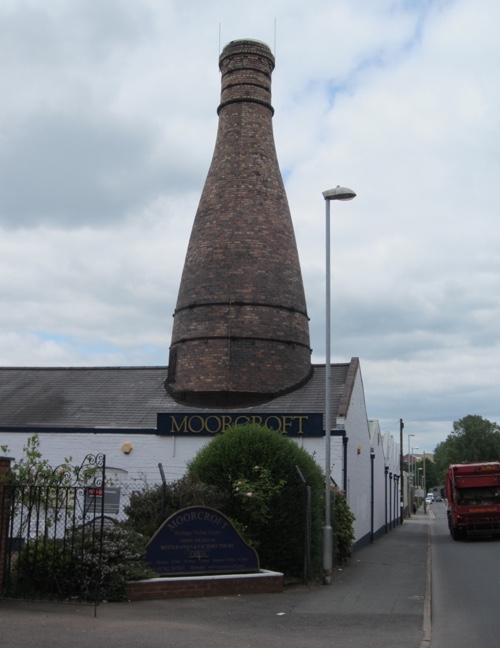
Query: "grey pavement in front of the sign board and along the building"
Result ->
[[0, 509, 431, 648]]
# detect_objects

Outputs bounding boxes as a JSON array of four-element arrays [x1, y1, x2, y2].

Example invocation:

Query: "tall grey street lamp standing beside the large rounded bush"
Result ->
[[323, 186, 356, 585]]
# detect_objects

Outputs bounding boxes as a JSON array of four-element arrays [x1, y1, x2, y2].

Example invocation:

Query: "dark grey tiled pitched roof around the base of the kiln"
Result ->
[[0, 358, 359, 430]]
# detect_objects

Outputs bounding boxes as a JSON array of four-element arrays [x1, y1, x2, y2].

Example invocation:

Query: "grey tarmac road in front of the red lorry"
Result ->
[[429, 502, 500, 648]]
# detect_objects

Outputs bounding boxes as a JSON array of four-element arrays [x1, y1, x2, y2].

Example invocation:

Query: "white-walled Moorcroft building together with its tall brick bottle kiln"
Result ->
[[0, 40, 399, 544]]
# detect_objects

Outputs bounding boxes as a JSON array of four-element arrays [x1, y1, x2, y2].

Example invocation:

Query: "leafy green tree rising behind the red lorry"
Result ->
[[434, 414, 500, 480]]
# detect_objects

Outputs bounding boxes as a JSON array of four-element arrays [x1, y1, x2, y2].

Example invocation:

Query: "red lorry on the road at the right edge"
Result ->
[[445, 462, 500, 540]]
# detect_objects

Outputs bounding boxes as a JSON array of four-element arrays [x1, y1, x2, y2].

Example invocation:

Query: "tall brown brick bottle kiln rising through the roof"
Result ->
[[166, 40, 311, 407]]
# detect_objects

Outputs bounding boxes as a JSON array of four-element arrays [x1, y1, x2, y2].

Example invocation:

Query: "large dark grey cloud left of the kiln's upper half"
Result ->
[[0, 114, 202, 228]]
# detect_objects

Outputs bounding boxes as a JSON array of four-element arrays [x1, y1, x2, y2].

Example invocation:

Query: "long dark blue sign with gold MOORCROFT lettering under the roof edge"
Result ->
[[157, 412, 323, 437]]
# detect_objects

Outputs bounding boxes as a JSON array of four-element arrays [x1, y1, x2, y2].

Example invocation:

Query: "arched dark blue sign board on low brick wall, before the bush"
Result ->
[[146, 506, 259, 576]]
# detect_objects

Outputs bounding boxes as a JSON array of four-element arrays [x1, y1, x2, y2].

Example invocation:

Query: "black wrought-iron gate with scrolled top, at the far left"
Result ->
[[0, 454, 106, 606]]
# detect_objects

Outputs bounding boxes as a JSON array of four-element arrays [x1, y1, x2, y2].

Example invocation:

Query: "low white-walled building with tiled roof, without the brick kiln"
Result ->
[[0, 358, 399, 544]]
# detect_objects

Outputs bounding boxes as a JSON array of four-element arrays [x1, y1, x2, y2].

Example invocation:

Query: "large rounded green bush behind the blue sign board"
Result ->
[[188, 425, 324, 576]]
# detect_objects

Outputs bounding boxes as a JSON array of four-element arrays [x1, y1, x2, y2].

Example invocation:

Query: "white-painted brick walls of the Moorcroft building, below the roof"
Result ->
[[0, 372, 399, 541]]
